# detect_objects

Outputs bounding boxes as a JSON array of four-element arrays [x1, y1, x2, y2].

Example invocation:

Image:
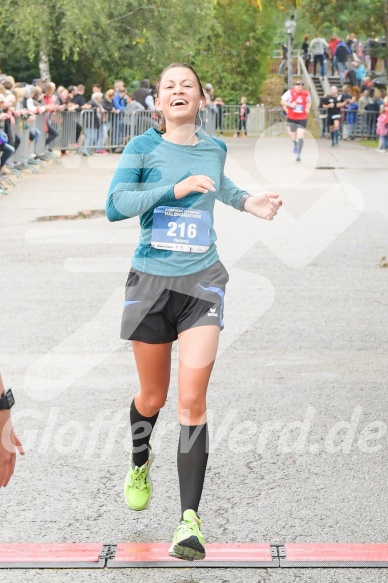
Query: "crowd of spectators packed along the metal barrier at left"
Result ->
[[0, 75, 161, 175]]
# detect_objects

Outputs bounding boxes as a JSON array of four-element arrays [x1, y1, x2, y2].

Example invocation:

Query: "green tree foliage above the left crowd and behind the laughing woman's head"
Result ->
[[0, 0, 275, 102]]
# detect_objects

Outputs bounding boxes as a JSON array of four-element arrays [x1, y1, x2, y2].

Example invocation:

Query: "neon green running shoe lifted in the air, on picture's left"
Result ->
[[124, 443, 154, 510]]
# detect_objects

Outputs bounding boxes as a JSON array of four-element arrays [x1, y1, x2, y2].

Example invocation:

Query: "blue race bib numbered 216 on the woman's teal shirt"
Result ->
[[151, 206, 211, 253]]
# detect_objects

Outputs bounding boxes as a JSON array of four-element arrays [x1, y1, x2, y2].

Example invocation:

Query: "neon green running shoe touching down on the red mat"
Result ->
[[168, 510, 206, 561]]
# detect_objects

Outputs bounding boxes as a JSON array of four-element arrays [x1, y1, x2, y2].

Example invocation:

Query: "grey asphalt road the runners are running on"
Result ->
[[0, 136, 388, 583]]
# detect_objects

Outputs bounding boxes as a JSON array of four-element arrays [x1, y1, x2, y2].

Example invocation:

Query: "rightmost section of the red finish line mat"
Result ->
[[278, 543, 388, 567]]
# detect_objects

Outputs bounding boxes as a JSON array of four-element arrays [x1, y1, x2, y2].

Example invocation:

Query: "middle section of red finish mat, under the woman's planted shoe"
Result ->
[[107, 543, 279, 568]]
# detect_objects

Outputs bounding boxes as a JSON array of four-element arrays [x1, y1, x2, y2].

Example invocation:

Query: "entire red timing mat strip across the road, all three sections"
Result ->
[[0, 543, 388, 569]]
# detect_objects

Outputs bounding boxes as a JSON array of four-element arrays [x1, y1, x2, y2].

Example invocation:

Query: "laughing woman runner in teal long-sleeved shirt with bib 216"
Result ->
[[106, 63, 282, 560]]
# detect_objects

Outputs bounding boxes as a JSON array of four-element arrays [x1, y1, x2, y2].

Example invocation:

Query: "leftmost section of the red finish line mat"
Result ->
[[0, 543, 105, 569]]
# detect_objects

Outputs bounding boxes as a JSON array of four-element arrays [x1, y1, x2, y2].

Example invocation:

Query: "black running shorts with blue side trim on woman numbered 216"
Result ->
[[120, 261, 229, 344]]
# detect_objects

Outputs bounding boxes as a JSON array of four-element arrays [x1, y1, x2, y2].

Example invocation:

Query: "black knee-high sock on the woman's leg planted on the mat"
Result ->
[[177, 423, 209, 515]]
